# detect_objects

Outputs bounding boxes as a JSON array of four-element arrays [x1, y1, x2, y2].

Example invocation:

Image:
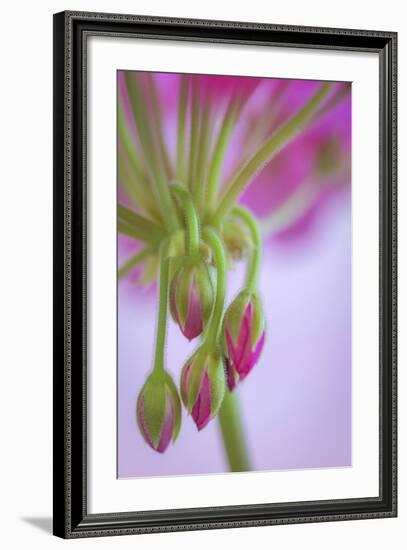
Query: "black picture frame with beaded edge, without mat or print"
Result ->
[[53, 11, 397, 538]]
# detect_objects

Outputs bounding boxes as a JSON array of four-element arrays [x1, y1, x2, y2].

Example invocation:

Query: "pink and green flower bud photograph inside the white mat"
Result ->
[[117, 70, 352, 479]]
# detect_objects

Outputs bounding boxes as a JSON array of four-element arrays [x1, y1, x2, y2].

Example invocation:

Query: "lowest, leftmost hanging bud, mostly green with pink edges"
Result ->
[[137, 372, 181, 453]]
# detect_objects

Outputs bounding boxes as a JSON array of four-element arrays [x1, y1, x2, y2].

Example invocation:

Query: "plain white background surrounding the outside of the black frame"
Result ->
[[0, 0, 407, 549]]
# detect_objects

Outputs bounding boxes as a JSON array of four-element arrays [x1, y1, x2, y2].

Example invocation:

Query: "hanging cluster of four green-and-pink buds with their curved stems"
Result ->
[[137, 201, 264, 453]]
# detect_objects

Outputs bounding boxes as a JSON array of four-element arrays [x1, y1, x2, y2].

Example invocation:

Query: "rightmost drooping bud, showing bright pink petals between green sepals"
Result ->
[[224, 290, 264, 390]]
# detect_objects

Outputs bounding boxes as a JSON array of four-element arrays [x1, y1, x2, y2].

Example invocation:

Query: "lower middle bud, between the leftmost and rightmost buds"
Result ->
[[181, 349, 225, 431]]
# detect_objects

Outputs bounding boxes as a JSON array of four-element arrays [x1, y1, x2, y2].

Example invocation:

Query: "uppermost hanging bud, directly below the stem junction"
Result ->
[[170, 259, 214, 340]]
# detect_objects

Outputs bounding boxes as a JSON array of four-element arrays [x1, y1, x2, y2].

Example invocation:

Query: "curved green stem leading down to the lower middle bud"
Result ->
[[203, 227, 226, 349]]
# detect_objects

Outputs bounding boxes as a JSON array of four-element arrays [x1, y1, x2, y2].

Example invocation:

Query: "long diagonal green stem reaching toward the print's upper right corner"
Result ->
[[212, 83, 332, 226]]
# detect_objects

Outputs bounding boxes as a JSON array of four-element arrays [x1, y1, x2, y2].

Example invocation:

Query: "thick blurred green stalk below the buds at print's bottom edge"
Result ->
[[218, 390, 251, 472]]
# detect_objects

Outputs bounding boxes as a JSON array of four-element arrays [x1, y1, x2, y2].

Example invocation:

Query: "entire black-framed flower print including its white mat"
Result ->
[[54, 12, 397, 538]]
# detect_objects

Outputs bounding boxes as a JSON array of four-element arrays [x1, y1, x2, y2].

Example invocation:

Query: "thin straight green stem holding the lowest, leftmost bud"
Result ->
[[154, 241, 169, 373]]
